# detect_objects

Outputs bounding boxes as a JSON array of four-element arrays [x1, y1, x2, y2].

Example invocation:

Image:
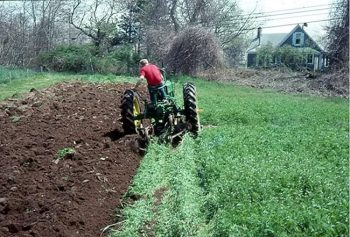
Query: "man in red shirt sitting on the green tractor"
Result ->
[[134, 59, 166, 104]]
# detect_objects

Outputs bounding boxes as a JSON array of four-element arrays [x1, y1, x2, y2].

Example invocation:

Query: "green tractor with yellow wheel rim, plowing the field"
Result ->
[[120, 70, 200, 144]]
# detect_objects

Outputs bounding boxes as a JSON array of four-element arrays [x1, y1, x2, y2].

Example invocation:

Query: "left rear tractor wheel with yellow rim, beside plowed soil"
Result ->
[[120, 90, 142, 134]]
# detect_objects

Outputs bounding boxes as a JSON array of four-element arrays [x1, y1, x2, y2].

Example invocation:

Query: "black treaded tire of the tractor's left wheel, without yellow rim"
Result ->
[[120, 90, 138, 134]]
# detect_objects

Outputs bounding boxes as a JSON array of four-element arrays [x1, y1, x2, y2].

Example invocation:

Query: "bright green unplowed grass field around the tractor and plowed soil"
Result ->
[[0, 71, 349, 237]]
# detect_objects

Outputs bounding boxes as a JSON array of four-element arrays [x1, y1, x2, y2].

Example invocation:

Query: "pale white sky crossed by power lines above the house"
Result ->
[[238, 0, 332, 40]]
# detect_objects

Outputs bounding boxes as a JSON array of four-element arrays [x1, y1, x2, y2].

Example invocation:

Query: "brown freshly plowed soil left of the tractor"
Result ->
[[0, 82, 145, 237]]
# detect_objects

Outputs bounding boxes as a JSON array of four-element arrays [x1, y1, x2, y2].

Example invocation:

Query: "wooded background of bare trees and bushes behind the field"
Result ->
[[0, 0, 349, 74]]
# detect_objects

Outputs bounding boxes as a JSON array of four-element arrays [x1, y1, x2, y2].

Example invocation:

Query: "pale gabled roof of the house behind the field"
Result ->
[[247, 24, 323, 53]]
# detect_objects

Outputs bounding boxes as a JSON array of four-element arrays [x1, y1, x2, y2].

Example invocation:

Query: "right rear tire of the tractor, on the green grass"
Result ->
[[183, 83, 200, 136]]
